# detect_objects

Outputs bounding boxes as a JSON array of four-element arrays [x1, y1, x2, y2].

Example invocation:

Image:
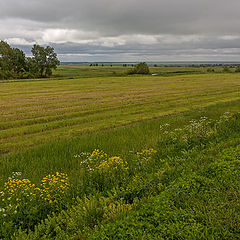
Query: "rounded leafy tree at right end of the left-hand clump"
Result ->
[[29, 44, 60, 77]]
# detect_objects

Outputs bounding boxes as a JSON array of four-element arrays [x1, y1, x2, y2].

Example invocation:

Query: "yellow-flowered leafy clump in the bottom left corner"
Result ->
[[0, 172, 69, 239]]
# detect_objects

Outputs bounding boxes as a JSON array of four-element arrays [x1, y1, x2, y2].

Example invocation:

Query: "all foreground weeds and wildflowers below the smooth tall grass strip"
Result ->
[[0, 110, 240, 239]]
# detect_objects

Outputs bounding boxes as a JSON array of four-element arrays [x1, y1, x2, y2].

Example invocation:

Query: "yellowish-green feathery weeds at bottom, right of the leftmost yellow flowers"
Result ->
[[16, 196, 132, 240]]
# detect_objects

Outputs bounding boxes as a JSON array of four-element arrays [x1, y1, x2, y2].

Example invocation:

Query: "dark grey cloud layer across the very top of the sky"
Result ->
[[0, 0, 240, 34]]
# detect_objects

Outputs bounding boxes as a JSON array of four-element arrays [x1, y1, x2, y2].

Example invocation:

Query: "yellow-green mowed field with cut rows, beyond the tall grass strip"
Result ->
[[0, 66, 240, 153]]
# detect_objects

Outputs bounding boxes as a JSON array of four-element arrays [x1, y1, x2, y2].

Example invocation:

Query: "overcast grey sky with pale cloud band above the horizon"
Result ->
[[0, 0, 240, 62]]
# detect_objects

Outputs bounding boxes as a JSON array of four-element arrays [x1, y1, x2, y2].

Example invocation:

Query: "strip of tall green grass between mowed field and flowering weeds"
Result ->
[[0, 101, 240, 184]]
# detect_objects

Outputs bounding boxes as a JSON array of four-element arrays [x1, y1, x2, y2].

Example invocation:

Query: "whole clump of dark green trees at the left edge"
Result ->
[[0, 41, 60, 79]]
